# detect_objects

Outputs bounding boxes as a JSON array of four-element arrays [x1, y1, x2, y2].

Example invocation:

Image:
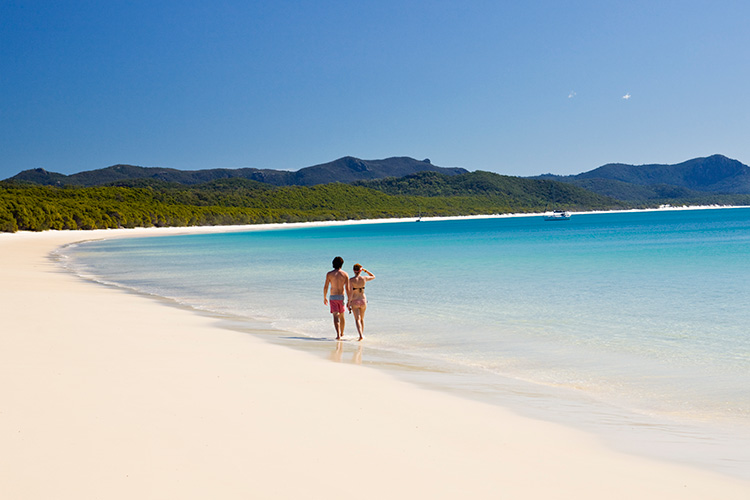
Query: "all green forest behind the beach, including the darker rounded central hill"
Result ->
[[0, 172, 636, 232]]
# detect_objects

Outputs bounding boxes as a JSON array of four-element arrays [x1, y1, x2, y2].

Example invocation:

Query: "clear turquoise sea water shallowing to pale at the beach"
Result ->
[[58, 209, 750, 473]]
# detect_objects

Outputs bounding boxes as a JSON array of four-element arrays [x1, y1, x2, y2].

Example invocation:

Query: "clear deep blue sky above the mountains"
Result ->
[[0, 0, 750, 179]]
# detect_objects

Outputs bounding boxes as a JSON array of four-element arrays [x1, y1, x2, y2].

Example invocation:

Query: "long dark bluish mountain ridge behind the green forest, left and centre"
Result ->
[[8, 156, 466, 187]]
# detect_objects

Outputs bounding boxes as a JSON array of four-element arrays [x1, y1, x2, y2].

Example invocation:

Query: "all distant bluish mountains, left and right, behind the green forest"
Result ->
[[8, 154, 750, 202]]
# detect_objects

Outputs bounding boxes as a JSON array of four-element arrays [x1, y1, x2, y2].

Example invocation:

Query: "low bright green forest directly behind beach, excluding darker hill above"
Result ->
[[0, 179, 608, 232]]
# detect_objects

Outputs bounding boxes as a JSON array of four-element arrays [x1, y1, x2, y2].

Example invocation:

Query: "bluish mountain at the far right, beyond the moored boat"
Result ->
[[534, 155, 750, 201]]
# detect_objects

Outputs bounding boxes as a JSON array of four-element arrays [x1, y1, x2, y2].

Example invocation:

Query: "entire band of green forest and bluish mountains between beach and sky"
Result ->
[[0, 155, 750, 232]]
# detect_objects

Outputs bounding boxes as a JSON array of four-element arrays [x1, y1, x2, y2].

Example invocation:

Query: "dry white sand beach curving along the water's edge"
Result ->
[[0, 228, 750, 500]]
